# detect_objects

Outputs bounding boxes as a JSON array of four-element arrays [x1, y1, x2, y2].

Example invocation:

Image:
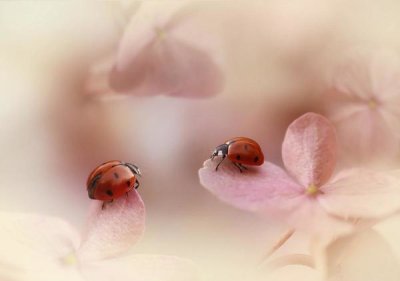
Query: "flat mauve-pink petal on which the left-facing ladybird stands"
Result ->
[[199, 159, 302, 211]]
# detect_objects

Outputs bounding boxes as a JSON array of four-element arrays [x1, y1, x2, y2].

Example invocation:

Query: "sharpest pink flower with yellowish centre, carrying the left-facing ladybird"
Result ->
[[199, 113, 400, 243]]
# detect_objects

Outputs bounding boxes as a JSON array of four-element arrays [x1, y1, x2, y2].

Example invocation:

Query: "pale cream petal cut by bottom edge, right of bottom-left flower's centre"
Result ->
[[82, 255, 200, 281]]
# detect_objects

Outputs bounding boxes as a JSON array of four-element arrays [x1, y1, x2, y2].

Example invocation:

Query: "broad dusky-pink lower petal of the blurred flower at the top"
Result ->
[[110, 37, 223, 98]]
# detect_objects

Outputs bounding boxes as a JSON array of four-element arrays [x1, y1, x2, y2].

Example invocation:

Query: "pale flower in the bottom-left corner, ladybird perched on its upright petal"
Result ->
[[0, 191, 197, 281]]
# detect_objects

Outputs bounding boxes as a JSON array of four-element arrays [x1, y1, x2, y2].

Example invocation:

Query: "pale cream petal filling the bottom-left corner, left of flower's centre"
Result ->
[[0, 212, 80, 281]]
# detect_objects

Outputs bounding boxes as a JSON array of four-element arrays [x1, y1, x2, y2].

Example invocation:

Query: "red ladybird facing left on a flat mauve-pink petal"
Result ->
[[210, 137, 264, 173]]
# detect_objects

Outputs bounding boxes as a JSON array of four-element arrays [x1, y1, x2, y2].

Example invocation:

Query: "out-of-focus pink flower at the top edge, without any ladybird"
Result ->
[[101, 1, 224, 98]]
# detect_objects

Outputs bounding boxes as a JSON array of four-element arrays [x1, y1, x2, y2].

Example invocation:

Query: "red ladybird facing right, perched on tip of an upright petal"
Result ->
[[86, 160, 141, 208]]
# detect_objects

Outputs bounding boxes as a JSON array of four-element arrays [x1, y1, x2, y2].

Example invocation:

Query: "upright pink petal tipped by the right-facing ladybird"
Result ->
[[78, 190, 145, 260]]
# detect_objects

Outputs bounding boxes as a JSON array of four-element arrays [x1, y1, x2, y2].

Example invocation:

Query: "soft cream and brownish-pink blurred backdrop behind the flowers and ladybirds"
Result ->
[[0, 0, 400, 281]]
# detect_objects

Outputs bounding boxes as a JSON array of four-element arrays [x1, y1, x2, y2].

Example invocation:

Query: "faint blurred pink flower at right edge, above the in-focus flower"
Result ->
[[325, 49, 400, 163]]
